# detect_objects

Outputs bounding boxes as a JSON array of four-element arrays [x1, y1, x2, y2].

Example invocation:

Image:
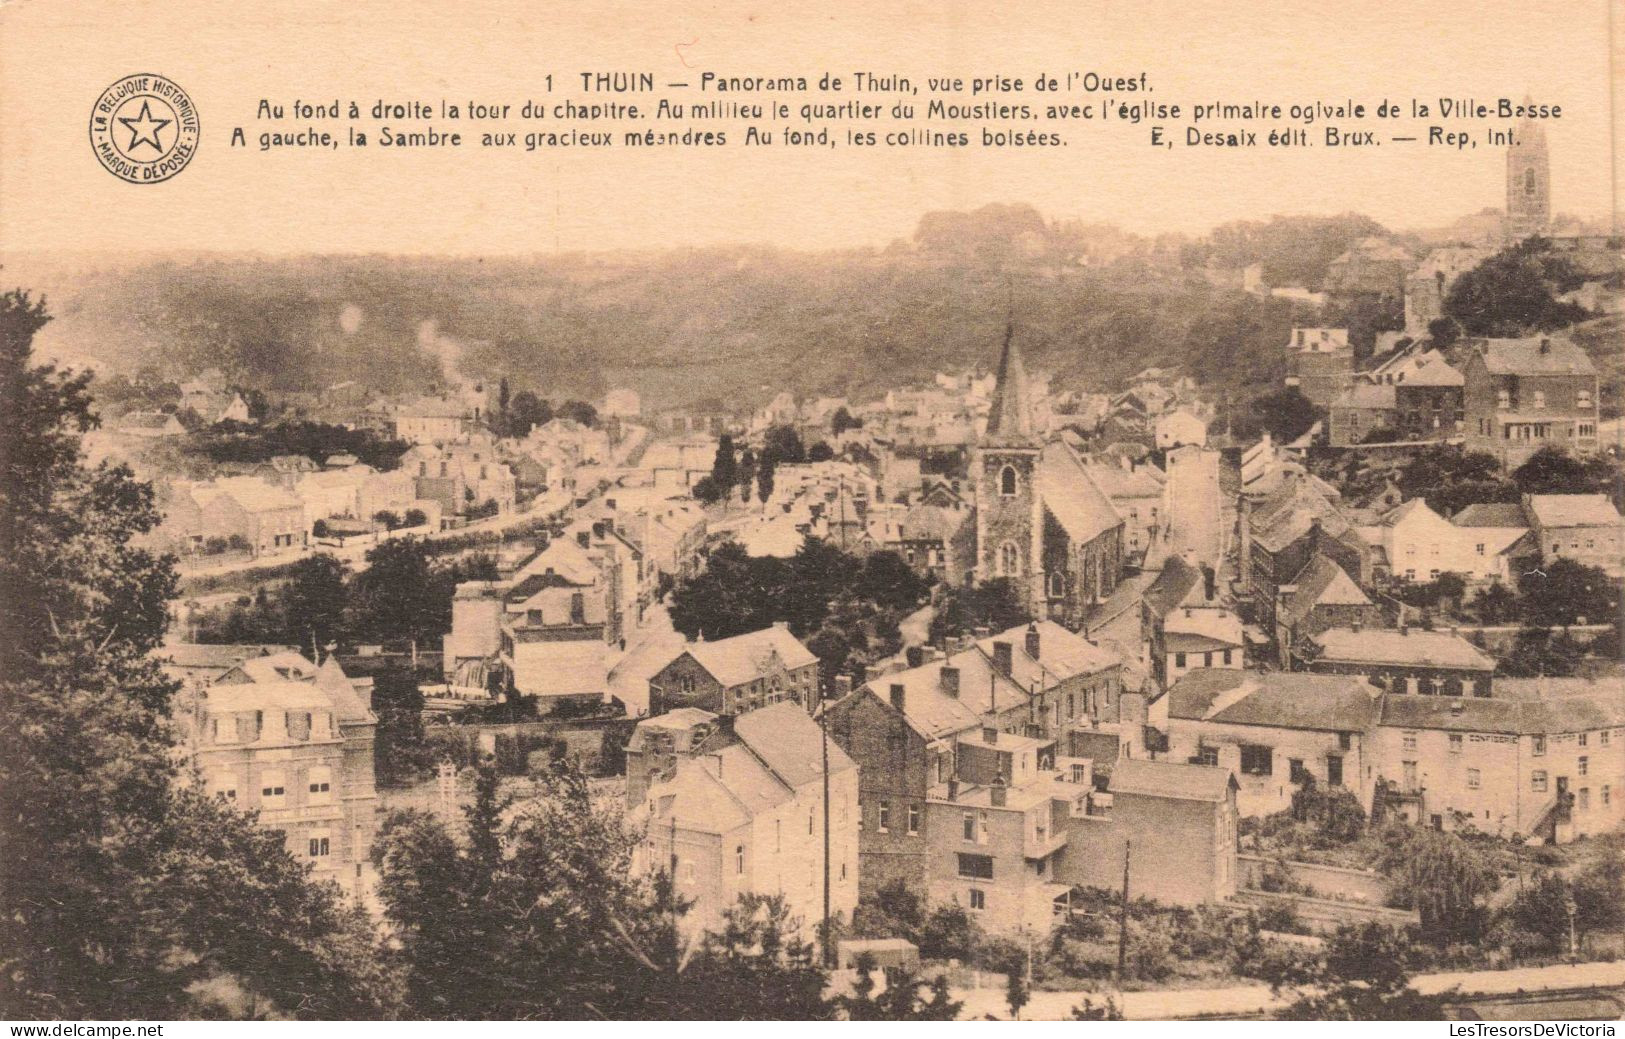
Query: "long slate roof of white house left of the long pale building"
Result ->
[[1168, 668, 1380, 732]]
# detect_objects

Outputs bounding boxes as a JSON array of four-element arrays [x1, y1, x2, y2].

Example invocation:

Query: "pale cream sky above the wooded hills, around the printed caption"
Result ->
[[0, 0, 1615, 254]]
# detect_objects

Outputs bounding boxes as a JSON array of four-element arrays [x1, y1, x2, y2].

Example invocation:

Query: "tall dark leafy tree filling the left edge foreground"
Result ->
[[0, 291, 395, 1018]]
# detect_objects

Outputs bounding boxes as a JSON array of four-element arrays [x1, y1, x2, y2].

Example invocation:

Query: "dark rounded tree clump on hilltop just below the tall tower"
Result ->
[[1445, 237, 1586, 337]]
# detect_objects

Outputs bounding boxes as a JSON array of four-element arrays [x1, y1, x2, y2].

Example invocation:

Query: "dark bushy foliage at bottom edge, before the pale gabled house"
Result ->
[[375, 759, 834, 1019]]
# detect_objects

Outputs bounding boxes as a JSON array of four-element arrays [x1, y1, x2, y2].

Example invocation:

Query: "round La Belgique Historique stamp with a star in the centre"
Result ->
[[91, 73, 198, 184]]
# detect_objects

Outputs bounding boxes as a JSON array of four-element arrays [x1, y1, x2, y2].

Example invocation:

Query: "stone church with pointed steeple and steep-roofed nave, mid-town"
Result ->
[[972, 328, 1123, 629]]
